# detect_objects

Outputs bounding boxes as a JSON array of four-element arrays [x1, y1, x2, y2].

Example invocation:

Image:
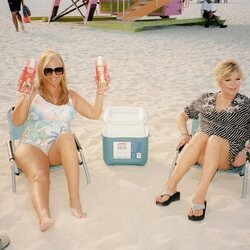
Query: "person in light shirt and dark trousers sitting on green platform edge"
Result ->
[[201, 0, 227, 28]]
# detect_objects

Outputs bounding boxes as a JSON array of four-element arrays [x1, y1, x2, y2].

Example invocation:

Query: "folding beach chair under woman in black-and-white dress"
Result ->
[[169, 120, 250, 198]]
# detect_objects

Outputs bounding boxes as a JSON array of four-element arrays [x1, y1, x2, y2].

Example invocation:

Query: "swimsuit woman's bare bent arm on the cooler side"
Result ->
[[69, 90, 103, 119]]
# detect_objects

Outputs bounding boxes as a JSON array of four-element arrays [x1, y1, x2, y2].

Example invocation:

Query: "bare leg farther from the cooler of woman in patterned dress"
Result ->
[[188, 135, 229, 216]]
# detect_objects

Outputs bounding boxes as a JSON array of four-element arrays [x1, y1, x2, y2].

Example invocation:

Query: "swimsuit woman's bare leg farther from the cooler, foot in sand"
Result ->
[[15, 144, 53, 231]]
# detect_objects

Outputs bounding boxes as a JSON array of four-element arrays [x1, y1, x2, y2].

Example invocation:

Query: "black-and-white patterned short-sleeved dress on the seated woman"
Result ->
[[185, 93, 250, 164]]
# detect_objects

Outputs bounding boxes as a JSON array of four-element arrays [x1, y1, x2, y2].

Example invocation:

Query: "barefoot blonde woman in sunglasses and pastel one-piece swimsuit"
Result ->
[[12, 50, 103, 231]]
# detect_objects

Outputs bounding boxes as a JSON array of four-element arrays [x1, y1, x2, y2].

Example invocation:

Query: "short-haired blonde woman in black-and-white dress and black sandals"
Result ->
[[156, 59, 250, 221]]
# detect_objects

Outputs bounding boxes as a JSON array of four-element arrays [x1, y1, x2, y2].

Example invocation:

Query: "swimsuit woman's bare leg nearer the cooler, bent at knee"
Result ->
[[49, 132, 86, 218]]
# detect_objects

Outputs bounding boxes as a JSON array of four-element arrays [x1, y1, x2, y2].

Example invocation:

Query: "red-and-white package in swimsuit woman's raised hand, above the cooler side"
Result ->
[[95, 56, 109, 92]]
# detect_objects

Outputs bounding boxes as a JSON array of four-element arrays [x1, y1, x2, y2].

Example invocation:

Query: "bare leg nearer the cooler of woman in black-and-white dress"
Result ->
[[156, 132, 208, 202]]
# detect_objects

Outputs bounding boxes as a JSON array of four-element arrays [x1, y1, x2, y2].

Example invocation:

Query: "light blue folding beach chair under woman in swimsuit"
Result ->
[[7, 107, 90, 192]]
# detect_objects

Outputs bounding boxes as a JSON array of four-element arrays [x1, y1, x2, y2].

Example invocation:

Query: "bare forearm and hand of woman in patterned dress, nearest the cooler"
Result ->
[[176, 111, 190, 149]]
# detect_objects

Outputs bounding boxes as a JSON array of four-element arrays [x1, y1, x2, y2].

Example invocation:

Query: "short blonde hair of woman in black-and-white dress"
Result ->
[[214, 58, 244, 84]]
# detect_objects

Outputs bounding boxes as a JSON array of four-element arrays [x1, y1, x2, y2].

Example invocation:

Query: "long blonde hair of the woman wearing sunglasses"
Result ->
[[37, 49, 69, 105]]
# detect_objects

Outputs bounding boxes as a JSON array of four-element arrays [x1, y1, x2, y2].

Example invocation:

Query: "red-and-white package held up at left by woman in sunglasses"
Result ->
[[18, 59, 36, 95]]
